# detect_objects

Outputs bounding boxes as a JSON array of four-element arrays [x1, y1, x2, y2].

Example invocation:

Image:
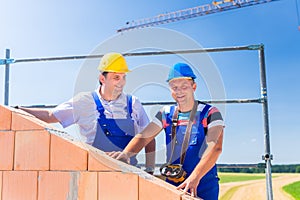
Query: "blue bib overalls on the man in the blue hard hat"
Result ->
[[164, 104, 219, 200]]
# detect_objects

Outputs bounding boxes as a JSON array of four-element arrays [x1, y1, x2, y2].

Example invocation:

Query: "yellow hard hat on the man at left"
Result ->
[[98, 52, 130, 73]]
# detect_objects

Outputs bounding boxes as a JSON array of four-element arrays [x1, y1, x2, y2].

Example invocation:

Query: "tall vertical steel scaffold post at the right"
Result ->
[[259, 45, 273, 200]]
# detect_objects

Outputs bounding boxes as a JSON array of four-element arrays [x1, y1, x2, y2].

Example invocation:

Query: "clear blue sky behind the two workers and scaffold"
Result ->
[[0, 0, 300, 164]]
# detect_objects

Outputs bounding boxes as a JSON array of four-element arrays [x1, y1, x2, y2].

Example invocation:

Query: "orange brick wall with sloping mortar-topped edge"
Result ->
[[0, 105, 199, 200]]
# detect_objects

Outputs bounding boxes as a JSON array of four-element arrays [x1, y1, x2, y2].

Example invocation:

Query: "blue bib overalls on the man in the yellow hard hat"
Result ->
[[92, 92, 137, 165]]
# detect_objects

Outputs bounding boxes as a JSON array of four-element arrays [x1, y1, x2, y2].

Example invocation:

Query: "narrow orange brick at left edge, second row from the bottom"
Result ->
[[0, 131, 15, 170]]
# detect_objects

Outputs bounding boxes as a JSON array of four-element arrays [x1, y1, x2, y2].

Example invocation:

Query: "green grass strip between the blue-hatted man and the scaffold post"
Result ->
[[218, 173, 265, 184]]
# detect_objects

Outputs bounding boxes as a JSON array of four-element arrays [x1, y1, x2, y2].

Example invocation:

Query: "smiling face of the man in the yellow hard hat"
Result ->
[[99, 72, 126, 101]]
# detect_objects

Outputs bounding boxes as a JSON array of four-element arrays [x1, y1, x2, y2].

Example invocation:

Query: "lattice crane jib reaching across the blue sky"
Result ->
[[117, 0, 276, 32]]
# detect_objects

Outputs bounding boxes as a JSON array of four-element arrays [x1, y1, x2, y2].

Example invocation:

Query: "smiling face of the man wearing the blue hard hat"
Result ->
[[169, 78, 196, 112]]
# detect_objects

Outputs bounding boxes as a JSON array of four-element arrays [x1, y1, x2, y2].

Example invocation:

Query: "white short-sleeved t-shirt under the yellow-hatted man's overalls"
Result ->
[[52, 88, 149, 144]]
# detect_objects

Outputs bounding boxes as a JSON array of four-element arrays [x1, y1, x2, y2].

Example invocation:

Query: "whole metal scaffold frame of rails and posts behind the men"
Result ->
[[0, 44, 273, 200]]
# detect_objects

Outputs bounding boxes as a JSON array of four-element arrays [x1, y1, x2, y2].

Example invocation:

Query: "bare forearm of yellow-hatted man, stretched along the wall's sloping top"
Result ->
[[19, 107, 59, 123]]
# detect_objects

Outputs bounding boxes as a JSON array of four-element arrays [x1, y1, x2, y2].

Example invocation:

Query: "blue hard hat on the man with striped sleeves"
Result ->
[[167, 63, 197, 82]]
